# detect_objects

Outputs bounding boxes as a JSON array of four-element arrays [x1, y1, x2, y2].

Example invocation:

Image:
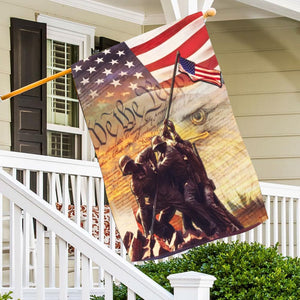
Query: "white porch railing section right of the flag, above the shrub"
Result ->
[[218, 182, 300, 257]]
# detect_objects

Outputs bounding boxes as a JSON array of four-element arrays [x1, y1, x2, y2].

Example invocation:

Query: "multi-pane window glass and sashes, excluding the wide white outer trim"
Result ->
[[47, 39, 82, 159]]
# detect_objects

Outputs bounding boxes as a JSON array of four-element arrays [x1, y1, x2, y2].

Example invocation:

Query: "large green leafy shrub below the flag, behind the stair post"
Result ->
[[94, 242, 300, 300]]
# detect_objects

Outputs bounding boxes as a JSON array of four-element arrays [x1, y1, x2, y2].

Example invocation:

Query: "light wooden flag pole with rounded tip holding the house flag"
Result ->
[[0, 8, 216, 102]]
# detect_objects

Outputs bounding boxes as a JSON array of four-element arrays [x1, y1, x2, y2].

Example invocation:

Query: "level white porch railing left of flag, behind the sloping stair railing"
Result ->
[[0, 151, 126, 288]]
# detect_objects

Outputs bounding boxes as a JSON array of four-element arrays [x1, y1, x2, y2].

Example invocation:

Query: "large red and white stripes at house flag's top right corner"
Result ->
[[126, 12, 218, 83]]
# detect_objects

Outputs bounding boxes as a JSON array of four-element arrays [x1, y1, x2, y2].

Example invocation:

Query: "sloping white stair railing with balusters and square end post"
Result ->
[[0, 152, 215, 300]]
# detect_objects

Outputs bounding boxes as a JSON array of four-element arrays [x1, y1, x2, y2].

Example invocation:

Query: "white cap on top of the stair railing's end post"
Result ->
[[167, 271, 217, 288]]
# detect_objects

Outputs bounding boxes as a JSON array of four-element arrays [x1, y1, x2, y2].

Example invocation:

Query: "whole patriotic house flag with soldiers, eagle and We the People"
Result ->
[[72, 12, 267, 261]]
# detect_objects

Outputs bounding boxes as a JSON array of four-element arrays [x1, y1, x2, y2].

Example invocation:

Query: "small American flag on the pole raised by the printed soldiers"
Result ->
[[178, 57, 223, 87]]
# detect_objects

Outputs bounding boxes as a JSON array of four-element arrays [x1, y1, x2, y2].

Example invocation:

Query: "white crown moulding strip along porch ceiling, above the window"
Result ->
[[50, 0, 145, 25]]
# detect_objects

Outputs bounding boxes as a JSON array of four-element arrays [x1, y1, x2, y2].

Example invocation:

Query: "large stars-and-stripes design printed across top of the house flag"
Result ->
[[72, 12, 218, 109]]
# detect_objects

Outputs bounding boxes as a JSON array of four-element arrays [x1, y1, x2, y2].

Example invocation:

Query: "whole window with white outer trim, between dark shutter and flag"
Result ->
[[38, 15, 94, 159]]
